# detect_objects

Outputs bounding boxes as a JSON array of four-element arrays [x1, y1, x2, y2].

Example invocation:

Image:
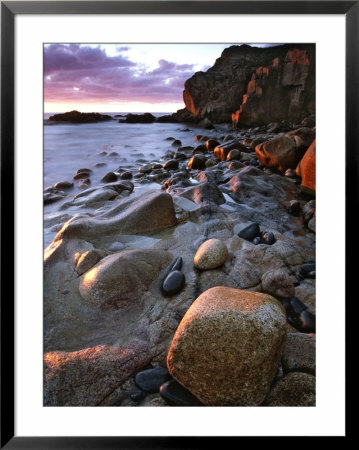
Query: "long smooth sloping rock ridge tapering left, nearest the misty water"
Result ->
[[55, 190, 177, 241]]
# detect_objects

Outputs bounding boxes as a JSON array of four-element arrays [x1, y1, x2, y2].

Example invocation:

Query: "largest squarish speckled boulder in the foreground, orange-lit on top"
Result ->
[[167, 286, 286, 406]]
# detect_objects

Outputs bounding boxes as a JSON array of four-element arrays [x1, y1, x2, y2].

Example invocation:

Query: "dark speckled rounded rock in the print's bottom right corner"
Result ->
[[263, 372, 315, 406]]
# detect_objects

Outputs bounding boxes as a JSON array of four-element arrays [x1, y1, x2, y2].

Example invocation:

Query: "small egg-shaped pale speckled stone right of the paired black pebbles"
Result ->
[[193, 239, 228, 270]]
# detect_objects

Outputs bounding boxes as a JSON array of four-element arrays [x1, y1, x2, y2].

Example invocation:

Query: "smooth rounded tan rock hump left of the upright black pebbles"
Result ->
[[79, 249, 172, 310]]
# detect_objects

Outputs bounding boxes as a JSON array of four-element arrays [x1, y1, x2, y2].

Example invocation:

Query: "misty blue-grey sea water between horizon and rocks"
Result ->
[[43, 113, 232, 246]]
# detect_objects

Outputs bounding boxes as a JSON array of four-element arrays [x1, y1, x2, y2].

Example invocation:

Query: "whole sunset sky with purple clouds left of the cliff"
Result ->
[[44, 44, 273, 113]]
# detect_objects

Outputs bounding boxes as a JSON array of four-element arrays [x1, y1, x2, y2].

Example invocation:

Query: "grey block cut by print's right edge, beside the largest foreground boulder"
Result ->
[[282, 333, 316, 375]]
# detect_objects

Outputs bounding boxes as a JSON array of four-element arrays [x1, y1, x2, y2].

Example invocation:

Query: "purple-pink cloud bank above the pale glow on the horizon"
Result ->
[[44, 44, 198, 103]]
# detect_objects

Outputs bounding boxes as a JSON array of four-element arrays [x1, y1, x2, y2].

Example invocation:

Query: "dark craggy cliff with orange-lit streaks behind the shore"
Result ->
[[182, 44, 315, 126]]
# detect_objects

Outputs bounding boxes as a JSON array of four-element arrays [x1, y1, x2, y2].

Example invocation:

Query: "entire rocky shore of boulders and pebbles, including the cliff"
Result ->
[[44, 44, 316, 407]]
